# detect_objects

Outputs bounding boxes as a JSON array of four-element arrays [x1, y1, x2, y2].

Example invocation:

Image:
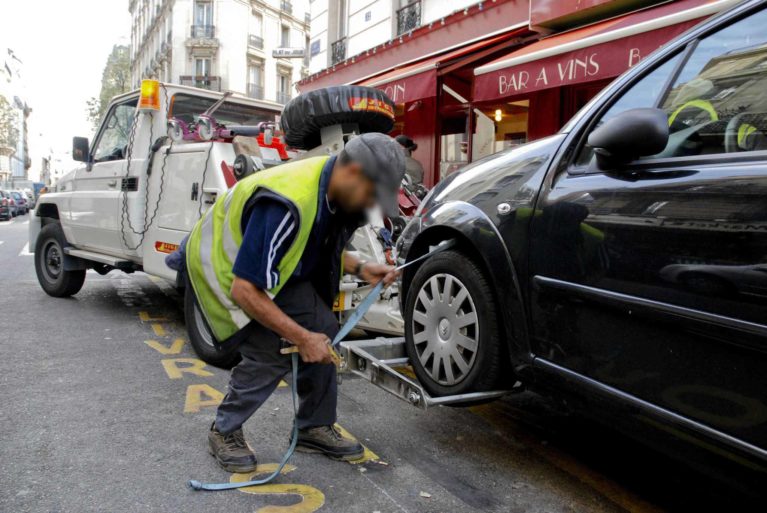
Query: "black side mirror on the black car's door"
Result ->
[[588, 109, 668, 170]]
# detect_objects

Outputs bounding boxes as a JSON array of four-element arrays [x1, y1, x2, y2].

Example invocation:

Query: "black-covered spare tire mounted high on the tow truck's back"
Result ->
[[281, 86, 394, 150]]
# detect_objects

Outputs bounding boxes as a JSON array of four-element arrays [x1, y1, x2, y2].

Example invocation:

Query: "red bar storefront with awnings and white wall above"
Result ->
[[299, 0, 736, 186]]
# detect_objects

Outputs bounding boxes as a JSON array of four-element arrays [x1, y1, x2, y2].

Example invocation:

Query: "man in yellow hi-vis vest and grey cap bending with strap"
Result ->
[[186, 133, 405, 472]]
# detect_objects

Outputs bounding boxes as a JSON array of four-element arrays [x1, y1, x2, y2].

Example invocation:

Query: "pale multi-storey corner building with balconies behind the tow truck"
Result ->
[[129, 0, 310, 104]]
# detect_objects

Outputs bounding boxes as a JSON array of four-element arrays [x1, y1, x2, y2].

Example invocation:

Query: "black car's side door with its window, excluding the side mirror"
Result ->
[[530, 11, 767, 454]]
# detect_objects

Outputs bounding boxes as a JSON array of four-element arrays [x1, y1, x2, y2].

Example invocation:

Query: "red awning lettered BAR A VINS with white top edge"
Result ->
[[473, 0, 732, 101]]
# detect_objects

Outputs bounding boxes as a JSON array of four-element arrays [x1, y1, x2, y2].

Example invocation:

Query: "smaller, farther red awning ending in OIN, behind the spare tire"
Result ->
[[357, 32, 516, 103]]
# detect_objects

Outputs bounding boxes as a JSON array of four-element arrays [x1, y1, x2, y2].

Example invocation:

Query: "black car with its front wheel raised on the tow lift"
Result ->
[[398, 2, 767, 494]]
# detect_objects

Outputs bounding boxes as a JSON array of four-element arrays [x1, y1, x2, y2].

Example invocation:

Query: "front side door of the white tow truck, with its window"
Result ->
[[70, 97, 143, 254]]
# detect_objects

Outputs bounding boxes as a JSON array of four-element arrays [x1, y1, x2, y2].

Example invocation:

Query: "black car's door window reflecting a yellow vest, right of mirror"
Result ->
[[658, 10, 767, 157]]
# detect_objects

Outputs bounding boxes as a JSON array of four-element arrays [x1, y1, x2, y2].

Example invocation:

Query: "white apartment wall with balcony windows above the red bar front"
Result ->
[[309, 0, 476, 73]]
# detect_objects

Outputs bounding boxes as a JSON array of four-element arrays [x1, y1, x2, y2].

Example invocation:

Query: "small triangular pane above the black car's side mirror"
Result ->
[[575, 54, 682, 166]]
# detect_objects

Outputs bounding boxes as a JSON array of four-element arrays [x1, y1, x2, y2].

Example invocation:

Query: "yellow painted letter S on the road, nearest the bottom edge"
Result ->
[[229, 463, 325, 513]]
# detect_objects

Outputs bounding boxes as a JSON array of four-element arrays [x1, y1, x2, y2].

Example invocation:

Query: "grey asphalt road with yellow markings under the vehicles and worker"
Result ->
[[0, 216, 756, 513]]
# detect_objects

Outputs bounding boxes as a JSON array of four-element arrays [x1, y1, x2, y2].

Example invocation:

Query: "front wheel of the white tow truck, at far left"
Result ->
[[35, 223, 85, 297]]
